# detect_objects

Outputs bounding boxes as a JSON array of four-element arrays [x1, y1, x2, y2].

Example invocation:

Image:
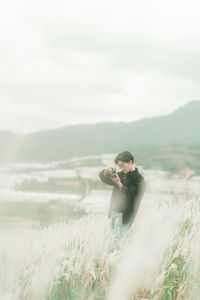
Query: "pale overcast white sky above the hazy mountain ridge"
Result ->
[[0, 0, 200, 133]]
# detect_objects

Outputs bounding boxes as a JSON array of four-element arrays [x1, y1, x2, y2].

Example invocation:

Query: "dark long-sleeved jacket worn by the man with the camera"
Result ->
[[99, 168, 146, 226]]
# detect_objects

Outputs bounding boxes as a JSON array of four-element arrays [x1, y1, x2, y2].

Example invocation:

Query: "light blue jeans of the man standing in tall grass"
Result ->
[[110, 211, 128, 250]]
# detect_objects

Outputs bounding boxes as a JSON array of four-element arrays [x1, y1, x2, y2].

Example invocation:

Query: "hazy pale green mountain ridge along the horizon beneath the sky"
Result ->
[[0, 101, 200, 162]]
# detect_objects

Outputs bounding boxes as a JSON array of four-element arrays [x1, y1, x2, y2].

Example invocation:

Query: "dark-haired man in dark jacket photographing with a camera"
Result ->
[[99, 151, 146, 250]]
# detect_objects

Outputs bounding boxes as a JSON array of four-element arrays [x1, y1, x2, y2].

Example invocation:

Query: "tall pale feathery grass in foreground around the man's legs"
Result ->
[[0, 191, 200, 300]]
